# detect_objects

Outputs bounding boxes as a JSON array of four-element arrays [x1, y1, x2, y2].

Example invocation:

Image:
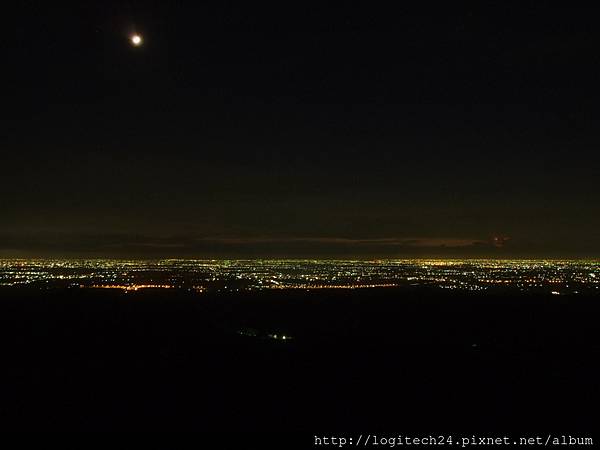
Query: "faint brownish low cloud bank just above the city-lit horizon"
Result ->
[[0, 233, 516, 258]]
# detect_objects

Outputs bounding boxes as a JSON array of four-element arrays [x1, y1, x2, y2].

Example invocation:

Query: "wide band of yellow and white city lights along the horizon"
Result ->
[[0, 259, 600, 294]]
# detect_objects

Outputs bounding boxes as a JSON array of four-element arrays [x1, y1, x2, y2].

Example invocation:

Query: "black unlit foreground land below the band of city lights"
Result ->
[[0, 289, 600, 433]]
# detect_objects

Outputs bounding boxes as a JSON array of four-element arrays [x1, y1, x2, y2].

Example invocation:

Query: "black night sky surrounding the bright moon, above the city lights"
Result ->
[[0, 1, 600, 258]]
